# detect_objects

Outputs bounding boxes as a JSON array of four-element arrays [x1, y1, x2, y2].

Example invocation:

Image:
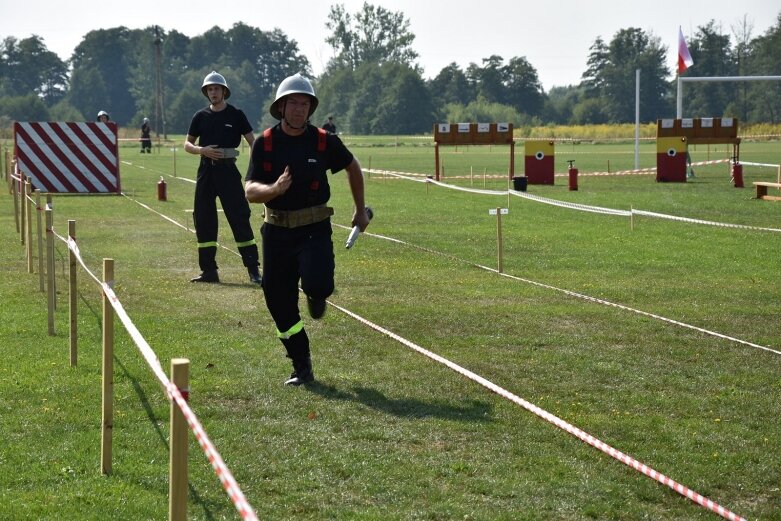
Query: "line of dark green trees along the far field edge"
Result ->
[[0, 3, 781, 134]]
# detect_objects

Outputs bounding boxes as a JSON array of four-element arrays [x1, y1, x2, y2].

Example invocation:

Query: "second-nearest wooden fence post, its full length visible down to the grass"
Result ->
[[100, 259, 114, 475]]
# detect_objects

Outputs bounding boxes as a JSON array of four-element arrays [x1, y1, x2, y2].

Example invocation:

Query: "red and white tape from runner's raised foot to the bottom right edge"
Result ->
[[331, 303, 745, 521]]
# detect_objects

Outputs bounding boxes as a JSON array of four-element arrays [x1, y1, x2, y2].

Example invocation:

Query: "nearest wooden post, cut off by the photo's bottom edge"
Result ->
[[168, 358, 190, 521]]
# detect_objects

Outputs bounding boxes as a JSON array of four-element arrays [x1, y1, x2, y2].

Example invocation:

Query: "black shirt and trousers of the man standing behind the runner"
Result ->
[[187, 104, 258, 272]]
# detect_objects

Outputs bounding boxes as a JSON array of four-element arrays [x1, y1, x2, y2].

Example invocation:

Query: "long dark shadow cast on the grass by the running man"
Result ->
[[305, 381, 492, 422]]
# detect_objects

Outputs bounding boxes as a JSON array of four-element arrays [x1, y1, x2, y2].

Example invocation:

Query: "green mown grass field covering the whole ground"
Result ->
[[0, 136, 781, 520]]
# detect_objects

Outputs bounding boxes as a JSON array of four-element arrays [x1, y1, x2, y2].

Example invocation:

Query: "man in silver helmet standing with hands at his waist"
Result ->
[[184, 71, 261, 284]]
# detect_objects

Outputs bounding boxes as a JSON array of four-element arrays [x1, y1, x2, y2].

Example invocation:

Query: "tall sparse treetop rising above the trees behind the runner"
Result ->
[[325, 2, 418, 69]]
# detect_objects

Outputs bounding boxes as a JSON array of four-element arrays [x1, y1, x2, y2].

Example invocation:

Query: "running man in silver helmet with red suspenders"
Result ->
[[245, 74, 369, 385]]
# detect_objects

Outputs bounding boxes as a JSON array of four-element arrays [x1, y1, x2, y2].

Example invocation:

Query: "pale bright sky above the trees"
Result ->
[[0, 0, 781, 92]]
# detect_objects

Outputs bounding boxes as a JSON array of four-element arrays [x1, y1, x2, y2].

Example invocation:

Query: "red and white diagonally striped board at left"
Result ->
[[14, 121, 120, 193]]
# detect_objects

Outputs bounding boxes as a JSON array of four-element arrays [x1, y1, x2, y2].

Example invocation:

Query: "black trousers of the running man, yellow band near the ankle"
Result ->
[[260, 219, 335, 360]]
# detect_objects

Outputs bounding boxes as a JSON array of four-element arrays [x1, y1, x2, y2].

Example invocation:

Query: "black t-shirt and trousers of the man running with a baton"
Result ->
[[246, 124, 353, 378]]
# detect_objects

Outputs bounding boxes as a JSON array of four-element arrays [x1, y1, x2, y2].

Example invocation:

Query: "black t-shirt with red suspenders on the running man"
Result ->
[[245, 124, 353, 210]]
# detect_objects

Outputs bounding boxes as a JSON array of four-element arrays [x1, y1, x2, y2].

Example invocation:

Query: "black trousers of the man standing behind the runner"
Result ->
[[193, 159, 258, 271]]
